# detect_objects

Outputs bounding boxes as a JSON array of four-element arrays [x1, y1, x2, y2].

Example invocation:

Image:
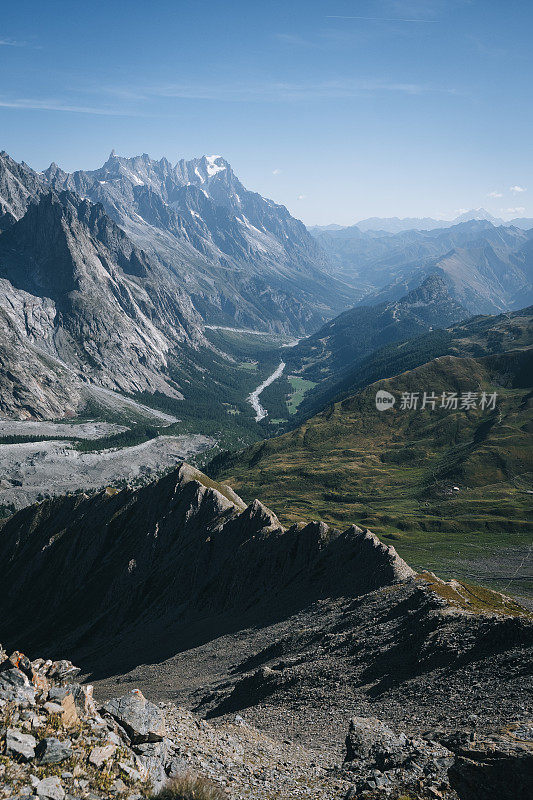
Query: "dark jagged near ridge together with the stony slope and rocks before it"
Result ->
[[0, 464, 533, 800]]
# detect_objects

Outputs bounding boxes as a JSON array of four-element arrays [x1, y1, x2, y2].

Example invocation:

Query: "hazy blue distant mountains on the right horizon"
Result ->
[[310, 220, 533, 314]]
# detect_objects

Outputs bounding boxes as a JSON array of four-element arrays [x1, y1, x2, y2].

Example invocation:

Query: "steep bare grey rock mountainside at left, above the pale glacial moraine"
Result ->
[[0, 192, 207, 418]]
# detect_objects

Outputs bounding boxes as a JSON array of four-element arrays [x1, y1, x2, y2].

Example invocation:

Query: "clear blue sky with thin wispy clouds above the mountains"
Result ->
[[0, 0, 533, 224]]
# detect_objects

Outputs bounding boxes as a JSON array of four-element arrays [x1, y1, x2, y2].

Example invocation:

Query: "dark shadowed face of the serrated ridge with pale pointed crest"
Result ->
[[0, 464, 414, 656]]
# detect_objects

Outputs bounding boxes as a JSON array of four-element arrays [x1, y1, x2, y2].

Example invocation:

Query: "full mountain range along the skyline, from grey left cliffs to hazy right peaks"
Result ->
[[0, 153, 533, 422]]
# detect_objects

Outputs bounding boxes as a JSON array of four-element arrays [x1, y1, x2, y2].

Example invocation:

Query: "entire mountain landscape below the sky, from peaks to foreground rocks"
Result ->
[[0, 151, 533, 800]]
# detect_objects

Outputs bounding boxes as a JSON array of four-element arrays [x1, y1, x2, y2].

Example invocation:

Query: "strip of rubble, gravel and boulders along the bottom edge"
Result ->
[[0, 649, 533, 800]]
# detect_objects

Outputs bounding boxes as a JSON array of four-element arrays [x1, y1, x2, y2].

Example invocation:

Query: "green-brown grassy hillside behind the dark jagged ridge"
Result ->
[[212, 351, 533, 591]]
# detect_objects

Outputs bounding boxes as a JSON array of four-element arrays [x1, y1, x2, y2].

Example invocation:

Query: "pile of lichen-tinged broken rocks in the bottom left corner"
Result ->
[[0, 647, 181, 800]]
